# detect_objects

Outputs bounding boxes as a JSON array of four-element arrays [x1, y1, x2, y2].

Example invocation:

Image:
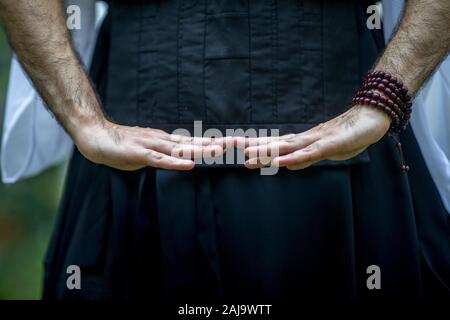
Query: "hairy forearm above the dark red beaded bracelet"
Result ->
[[374, 0, 450, 95]]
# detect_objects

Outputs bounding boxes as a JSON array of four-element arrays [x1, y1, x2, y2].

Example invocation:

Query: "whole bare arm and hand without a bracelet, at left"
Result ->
[[0, 0, 224, 170]]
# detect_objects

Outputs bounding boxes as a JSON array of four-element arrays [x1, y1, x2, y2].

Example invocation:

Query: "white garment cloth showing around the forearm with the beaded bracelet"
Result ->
[[383, 0, 450, 213]]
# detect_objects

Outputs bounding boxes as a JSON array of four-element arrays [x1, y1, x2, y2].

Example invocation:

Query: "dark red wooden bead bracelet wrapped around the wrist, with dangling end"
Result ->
[[350, 71, 412, 172]]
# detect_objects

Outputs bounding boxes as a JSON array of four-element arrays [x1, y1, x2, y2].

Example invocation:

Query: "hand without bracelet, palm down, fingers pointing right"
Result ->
[[73, 120, 228, 171]]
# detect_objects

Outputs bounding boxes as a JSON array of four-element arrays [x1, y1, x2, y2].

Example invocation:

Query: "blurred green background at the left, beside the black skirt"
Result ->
[[0, 29, 64, 300]]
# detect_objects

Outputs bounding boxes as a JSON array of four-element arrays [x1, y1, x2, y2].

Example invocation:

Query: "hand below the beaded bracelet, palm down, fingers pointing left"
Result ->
[[236, 106, 391, 170]]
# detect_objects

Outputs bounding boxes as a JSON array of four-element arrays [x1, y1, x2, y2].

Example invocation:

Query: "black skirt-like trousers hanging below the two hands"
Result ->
[[45, 122, 450, 302]]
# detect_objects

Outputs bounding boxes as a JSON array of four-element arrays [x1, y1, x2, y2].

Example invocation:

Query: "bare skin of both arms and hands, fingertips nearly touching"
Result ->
[[0, 0, 450, 170]]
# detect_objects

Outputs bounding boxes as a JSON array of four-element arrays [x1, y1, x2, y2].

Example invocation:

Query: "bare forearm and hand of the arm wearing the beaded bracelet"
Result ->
[[242, 0, 450, 170]]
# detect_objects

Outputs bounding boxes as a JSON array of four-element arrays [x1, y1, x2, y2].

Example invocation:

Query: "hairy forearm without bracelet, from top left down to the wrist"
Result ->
[[0, 0, 104, 137]]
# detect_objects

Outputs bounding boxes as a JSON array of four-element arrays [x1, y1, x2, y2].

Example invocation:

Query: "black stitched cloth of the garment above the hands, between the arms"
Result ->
[[93, 0, 382, 161]]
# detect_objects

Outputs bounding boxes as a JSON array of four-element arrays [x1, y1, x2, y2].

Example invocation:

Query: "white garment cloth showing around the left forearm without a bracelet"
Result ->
[[0, 0, 106, 183]]
